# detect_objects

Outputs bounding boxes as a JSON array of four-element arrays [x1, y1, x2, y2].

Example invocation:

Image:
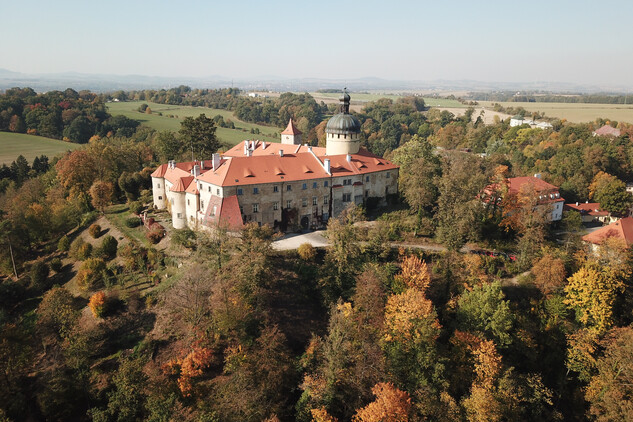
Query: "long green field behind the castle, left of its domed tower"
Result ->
[[107, 101, 282, 145]]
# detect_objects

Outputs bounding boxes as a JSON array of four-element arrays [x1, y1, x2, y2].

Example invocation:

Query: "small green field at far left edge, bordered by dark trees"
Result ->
[[0, 132, 81, 165]]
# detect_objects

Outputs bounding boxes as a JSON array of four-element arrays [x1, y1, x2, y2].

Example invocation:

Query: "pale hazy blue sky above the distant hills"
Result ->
[[0, 0, 633, 88]]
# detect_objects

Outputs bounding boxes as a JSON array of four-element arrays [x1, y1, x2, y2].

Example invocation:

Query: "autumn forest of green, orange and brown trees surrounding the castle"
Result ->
[[0, 89, 633, 422]]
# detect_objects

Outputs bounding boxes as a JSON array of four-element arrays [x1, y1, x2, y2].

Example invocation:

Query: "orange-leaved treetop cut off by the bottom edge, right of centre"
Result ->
[[352, 382, 411, 422]]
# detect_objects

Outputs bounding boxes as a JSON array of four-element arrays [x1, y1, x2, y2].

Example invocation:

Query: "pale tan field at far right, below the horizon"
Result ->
[[479, 101, 633, 123]]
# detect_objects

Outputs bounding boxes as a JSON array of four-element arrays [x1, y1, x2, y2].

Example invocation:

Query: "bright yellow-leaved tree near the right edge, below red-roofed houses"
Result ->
[[564, 263, 624, 333]]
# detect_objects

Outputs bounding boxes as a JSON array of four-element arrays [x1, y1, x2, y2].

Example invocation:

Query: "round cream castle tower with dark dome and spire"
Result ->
[[325, 88, 360, 155]]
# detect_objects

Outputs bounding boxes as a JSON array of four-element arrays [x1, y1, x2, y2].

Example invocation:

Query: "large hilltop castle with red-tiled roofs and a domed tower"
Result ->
[[152, 92, 398, 231]]
